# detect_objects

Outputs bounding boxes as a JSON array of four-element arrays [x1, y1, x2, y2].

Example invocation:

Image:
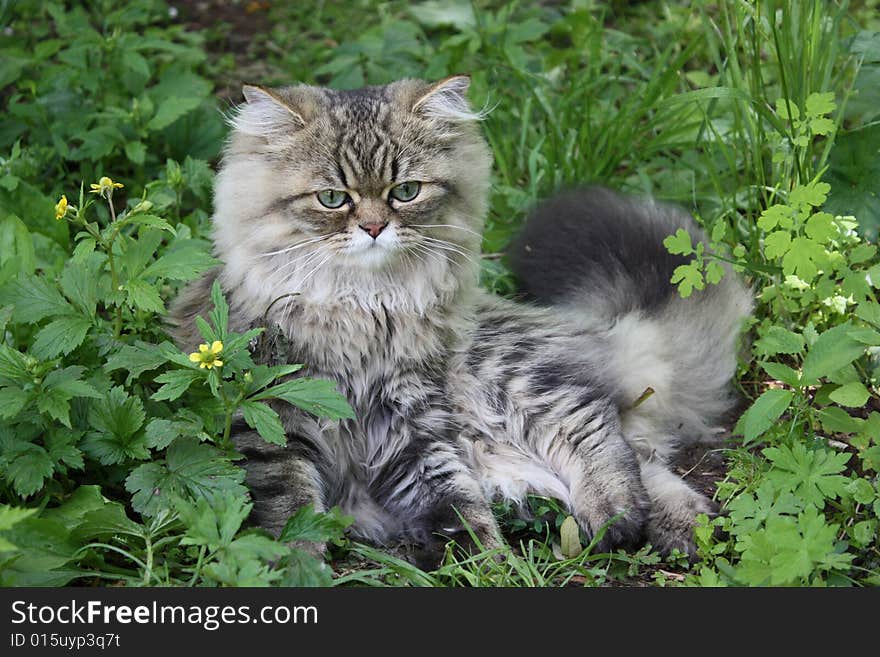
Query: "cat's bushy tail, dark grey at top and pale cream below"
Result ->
[[511, 187, 752, 458]]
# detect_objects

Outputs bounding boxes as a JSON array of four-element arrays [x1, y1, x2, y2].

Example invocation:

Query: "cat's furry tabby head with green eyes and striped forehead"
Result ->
[[214, 76, 491, 310]]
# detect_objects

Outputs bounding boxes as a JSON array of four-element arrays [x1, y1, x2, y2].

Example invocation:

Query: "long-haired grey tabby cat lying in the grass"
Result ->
[[172, 76, 750, 563]]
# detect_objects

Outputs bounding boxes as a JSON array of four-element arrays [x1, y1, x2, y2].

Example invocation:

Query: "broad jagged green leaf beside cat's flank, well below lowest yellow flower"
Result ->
[[125, 437, 247, 516]]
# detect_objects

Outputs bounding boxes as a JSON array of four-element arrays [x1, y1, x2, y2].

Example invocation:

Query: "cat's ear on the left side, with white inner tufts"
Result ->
[[232, 84, 311, 137]]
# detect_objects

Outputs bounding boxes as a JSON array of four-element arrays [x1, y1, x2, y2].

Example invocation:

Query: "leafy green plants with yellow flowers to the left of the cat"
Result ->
[[0, 133, 352, 586]]
